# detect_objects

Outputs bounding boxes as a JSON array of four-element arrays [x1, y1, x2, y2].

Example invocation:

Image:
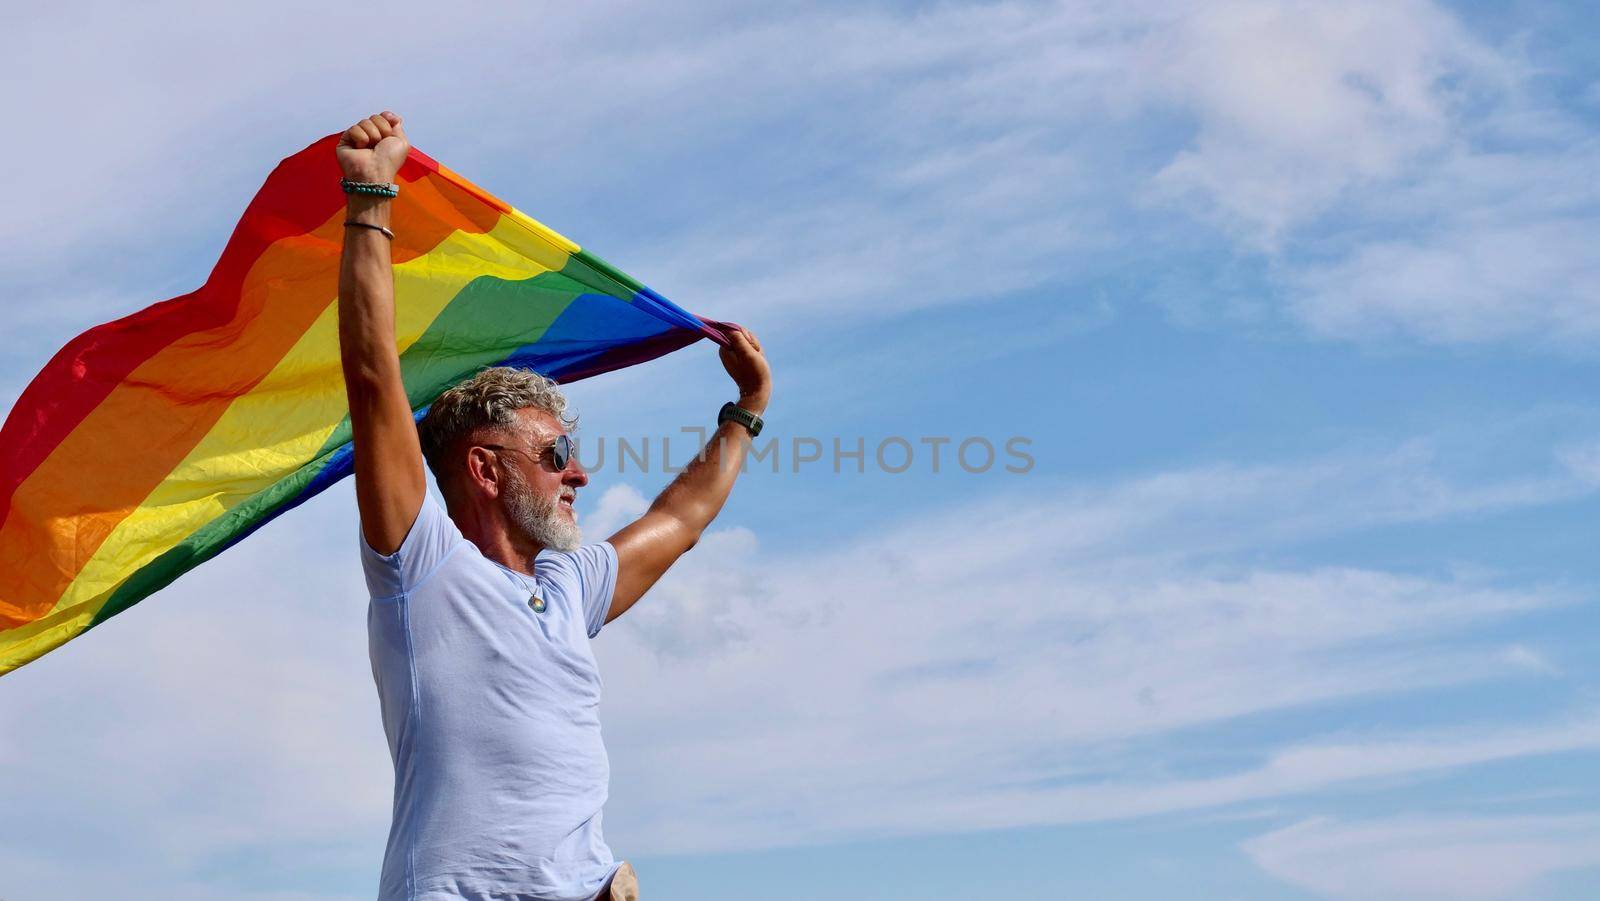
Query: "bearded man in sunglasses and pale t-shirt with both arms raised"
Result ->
[[338, 112, 771, 901]]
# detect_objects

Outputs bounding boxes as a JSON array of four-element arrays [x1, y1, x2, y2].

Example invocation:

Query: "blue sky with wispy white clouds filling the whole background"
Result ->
[[0, 0, 1600, 901]]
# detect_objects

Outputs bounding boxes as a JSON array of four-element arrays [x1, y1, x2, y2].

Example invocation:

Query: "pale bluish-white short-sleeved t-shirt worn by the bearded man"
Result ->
[[360, 496, 618, 901]]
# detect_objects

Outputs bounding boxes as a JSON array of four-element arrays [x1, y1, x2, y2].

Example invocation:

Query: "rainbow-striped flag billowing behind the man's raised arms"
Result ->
[[0, 136, 726, 674]]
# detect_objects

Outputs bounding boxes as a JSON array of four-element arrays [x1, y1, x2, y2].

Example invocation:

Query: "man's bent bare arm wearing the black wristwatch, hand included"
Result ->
[[605, 330, 773, 623]]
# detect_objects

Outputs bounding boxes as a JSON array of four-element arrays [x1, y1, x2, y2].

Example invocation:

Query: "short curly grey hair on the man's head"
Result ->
[[418, 366, 578, 487]]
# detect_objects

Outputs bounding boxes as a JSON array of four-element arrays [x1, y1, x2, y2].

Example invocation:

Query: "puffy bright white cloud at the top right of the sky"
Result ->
[[1149, 0, 1510, 248]]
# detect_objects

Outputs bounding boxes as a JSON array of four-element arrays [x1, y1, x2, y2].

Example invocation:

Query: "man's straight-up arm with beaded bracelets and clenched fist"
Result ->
[[336, 112, 427, 554]]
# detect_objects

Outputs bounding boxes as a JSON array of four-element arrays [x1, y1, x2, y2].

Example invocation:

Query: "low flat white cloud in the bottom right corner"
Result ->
[[1243, 815, 1600, 901]]
